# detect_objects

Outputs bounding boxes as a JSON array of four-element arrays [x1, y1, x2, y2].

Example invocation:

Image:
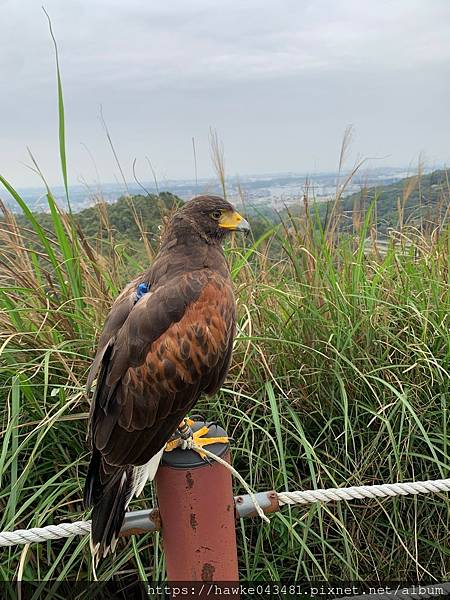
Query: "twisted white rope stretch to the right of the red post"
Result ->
[[278, 479, 450, 506]]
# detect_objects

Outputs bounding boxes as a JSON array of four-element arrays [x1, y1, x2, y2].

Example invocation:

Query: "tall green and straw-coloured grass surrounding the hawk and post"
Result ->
[[0, 21, 450, 581]]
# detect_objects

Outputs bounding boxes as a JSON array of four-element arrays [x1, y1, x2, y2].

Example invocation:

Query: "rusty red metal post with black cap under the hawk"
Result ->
[[156, 423, 238, 582]]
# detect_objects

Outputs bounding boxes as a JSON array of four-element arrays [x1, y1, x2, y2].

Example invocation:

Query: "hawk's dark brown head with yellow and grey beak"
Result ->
[[171, 195, 250, 243]]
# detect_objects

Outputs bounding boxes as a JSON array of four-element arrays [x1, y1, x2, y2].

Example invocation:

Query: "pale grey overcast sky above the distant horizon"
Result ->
[[0, 0, 450, 186]]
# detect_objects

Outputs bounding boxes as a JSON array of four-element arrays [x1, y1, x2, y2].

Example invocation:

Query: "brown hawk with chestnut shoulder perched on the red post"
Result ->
[[84, 196, 248, 560]]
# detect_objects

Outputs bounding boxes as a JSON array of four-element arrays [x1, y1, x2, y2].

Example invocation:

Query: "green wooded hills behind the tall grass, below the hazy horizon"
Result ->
[[6, 170, 450, 255]]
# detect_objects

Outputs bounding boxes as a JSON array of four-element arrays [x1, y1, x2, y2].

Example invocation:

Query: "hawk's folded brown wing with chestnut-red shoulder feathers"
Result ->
[[87, 270, 235, 466]]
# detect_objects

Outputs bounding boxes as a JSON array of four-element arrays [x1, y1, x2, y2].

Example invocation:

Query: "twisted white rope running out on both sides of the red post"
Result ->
[[0, 478, 450, 547]]
